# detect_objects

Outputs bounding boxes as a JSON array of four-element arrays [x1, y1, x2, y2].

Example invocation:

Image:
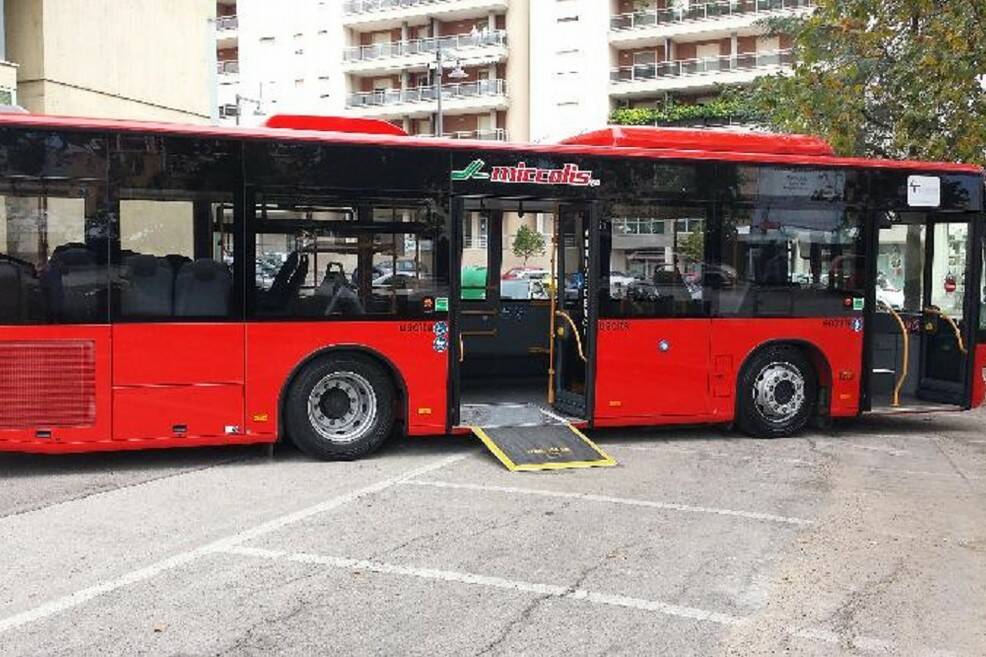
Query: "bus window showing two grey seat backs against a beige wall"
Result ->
[[112, 135, 239, 321]]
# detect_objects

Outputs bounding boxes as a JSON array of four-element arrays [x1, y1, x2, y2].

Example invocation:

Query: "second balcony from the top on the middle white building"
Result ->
[[343, 30, 507, 75]]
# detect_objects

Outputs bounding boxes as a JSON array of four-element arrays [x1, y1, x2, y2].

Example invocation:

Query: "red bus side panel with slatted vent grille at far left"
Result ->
[[0, 325, 112, 452]]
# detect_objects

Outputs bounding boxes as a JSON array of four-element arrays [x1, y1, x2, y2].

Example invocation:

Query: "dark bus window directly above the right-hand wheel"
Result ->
[[718, 203, 866, 317]]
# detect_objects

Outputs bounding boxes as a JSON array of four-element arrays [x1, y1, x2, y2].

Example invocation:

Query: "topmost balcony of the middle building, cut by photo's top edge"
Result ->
[[342, 0, 510, 30]]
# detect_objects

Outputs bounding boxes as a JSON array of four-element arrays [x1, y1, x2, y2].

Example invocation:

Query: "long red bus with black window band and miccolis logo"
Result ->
[[0, 114, 986, 459]]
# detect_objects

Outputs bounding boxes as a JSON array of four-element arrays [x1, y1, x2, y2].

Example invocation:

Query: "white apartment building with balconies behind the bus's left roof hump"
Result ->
[[217, 0, 530, 140]]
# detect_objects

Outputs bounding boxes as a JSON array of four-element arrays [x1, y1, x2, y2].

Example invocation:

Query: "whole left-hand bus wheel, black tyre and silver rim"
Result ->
[[284, 354, 394, 460]]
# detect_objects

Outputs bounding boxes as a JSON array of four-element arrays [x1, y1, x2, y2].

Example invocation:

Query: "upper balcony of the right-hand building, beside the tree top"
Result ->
[[609, 0, 815, 48]]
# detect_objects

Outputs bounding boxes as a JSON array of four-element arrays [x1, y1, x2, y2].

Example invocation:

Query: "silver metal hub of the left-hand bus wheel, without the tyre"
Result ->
[[308, 372, 377, 443]]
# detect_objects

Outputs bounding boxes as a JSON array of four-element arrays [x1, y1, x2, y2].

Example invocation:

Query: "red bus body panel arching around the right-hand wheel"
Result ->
[[711, 316, 863, 421]]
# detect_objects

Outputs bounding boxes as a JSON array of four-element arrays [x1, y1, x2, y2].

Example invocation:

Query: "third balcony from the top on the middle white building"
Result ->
[[346, 80, 509, 118]]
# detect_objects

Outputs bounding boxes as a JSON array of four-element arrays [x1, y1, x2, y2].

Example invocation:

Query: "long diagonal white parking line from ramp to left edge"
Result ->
[[0, 452, 472, 634]]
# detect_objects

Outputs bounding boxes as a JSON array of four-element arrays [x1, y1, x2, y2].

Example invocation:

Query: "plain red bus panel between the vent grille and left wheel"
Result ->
[[113, 323, 244, 440]]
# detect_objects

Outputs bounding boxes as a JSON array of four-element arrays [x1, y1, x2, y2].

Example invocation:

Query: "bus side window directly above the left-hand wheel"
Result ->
[[252, 197, 448, 318]]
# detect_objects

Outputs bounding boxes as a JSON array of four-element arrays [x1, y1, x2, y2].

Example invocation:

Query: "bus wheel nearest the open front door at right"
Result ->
[[736, 346, 818, 438]]
